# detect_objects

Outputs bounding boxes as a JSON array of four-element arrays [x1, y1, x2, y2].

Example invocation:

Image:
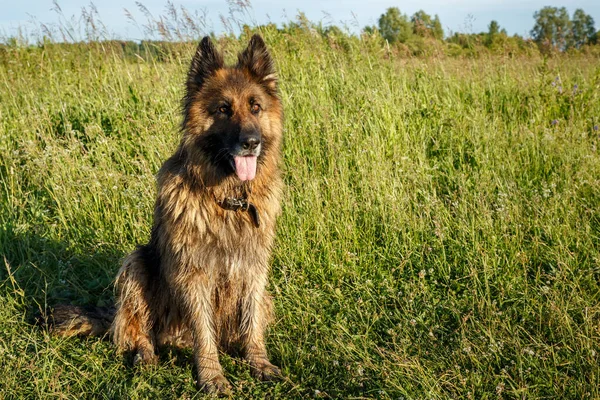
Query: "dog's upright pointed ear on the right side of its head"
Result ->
[[237, 34, 277, 91]]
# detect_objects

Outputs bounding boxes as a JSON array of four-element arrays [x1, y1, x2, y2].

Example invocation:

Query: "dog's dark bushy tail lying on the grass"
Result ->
[[38, 304, 115, 337]]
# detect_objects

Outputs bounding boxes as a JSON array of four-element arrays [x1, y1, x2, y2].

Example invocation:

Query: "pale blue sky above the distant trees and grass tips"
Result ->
[[0, 0, 600, 40]]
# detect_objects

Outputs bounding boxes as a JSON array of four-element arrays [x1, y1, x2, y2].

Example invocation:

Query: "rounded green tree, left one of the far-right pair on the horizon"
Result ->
[[531, 7, 572, 51]]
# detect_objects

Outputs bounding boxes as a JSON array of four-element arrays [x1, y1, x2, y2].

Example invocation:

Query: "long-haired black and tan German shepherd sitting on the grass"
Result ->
[[52, 35, 283, 393]]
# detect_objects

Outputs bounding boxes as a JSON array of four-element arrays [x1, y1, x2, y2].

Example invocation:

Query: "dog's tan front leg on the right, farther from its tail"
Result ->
[[240, 273, 281, 381]]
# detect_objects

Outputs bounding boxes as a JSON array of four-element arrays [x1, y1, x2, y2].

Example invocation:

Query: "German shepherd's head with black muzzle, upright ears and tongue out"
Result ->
[[183, 35, 282, 181]]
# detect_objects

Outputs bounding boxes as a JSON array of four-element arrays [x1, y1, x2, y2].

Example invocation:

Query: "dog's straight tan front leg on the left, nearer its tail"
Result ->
[[173, 273, 231, 394]]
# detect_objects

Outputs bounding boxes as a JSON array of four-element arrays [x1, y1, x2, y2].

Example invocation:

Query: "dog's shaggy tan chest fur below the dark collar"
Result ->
[[155, 168, 279, 279]]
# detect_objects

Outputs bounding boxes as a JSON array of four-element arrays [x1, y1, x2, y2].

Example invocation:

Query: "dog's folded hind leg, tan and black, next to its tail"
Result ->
[[112, 248, 157, 364]]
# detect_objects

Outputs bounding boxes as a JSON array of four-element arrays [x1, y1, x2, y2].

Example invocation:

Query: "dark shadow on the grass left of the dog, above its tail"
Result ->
[[0, 226, 124, 317]]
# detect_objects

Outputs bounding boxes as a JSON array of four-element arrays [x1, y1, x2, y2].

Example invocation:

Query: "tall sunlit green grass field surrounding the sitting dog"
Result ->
[[0, 26, 600, 399]]
